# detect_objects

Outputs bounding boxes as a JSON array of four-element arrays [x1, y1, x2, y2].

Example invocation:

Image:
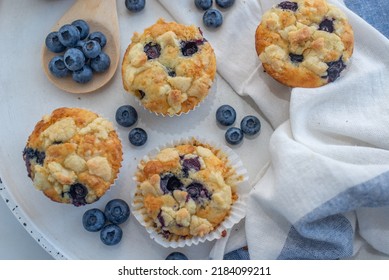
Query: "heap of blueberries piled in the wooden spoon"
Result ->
[[45, 19, 111, 84]]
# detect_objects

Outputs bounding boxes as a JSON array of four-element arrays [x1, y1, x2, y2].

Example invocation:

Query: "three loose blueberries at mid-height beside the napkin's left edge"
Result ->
[[216, 104, 261, 145]]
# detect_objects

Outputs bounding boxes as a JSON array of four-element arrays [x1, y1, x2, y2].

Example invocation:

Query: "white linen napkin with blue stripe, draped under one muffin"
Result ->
[[159, 0, 389, 259]]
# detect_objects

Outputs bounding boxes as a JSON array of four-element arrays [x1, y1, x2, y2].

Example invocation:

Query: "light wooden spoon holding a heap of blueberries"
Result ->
[[42, 0, 120, 93]]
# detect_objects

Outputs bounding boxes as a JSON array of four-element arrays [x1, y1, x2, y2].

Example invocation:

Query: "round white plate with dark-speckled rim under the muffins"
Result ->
[[0, 0, 272, 259]]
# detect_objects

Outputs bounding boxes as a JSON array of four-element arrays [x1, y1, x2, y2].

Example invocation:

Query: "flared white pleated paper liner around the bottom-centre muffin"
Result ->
[[131, 137, 250, 248]]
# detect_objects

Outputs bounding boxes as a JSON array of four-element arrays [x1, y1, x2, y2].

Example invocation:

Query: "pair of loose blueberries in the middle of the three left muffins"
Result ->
[[115, 105, 147, 146]]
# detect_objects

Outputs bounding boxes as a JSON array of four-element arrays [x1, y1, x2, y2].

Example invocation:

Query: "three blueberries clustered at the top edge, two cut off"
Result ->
[[194, 0, 235, 28]]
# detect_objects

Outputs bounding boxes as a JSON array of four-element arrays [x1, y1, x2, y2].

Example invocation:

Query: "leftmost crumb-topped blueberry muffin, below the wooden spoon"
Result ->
[[23, 108, 122, 206]]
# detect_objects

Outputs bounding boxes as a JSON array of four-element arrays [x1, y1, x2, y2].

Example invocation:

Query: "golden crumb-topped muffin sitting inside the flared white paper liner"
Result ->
[[133, 139, 242, 242]]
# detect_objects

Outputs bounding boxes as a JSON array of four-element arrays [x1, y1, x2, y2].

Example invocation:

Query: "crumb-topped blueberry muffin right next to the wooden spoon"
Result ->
[[122, 19, 216, 116]]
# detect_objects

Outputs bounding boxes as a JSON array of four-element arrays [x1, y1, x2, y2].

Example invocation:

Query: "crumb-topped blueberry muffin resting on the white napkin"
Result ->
[[255, 0, 354, 88]]
